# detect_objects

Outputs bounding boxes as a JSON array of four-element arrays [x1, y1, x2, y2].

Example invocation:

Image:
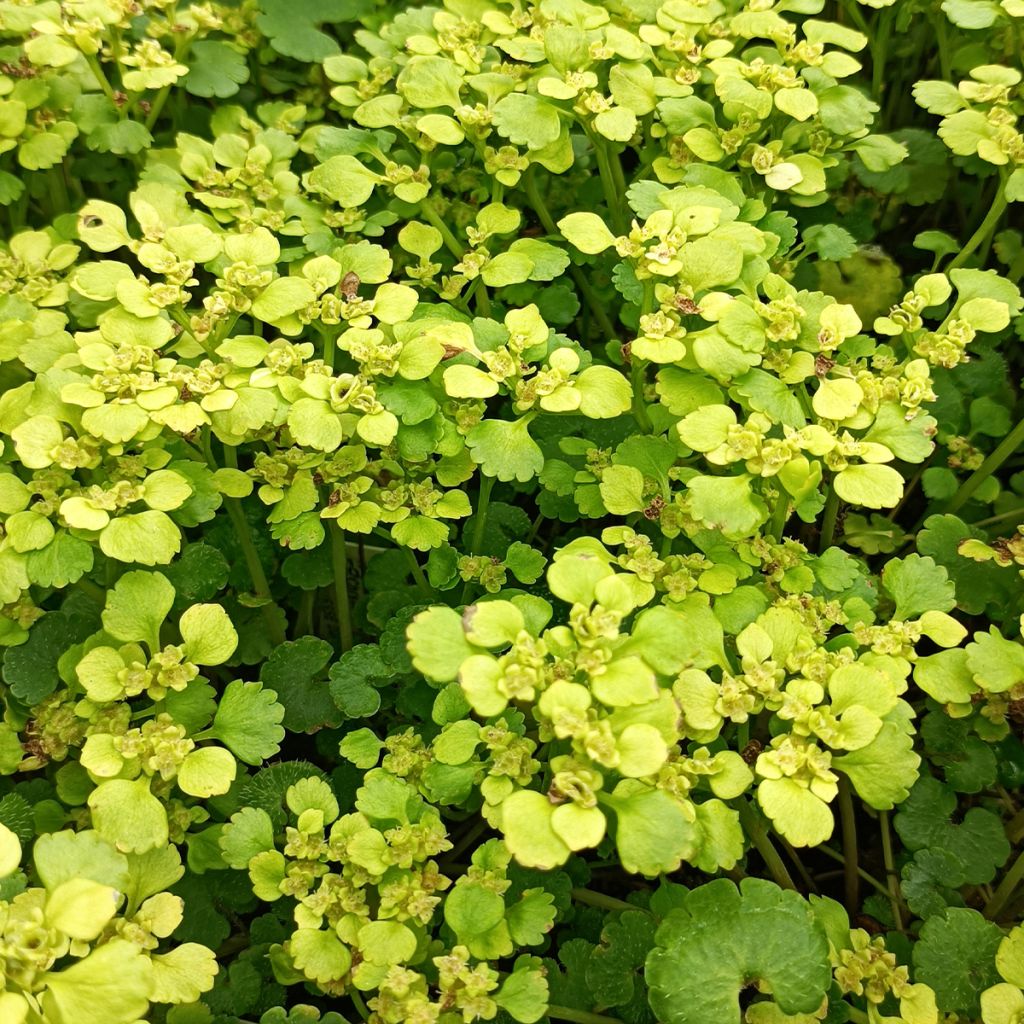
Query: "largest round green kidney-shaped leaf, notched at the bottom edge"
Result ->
[[646, 879, 831, 1024]]
